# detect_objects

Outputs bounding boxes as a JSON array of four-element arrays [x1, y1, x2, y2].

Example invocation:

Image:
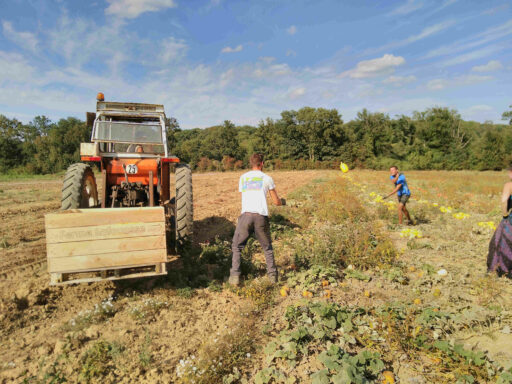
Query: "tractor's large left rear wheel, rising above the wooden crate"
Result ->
[[61, 163, 98, 209]]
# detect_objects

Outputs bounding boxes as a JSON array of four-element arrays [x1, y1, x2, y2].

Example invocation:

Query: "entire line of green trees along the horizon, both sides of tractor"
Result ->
[[0, 106, 512, 174]]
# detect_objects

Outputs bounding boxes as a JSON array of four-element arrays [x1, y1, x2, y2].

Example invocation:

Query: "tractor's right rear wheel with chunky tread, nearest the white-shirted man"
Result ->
[[174, 164, 194, 248]]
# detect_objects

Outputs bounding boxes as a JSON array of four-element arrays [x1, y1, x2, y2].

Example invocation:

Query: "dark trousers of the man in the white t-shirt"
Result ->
[[230, 212, 277, 276]]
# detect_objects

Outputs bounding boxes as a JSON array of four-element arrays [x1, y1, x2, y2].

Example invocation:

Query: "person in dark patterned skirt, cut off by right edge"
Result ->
[[487, 166, 512, 278]]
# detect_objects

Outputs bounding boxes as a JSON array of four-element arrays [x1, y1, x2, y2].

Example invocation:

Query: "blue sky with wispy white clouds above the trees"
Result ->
[[0, 0, 512, 128]]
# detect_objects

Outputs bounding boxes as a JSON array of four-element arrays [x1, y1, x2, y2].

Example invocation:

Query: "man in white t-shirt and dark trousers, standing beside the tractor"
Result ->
[[229, 153, 285, 285]]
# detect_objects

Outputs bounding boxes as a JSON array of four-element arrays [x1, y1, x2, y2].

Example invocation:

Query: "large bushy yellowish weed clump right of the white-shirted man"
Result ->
[[293, 178, 397, 270]]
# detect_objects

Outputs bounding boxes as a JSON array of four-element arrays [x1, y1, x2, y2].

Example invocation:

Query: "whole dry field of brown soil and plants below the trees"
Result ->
[[0, 170, 512, 383]]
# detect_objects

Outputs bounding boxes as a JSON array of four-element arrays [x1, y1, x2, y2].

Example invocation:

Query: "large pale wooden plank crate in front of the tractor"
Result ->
[[45, 207, 167, 284]]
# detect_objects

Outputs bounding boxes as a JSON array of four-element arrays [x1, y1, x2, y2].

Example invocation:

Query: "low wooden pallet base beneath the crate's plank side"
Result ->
[[50, 263, 167, 285]]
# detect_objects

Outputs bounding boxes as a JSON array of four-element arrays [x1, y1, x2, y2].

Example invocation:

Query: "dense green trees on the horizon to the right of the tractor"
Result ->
[[173, 107, 512, 170]]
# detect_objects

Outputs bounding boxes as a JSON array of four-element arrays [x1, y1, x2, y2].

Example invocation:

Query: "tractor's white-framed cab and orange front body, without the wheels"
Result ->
[[80, 94, 179, 208]]
